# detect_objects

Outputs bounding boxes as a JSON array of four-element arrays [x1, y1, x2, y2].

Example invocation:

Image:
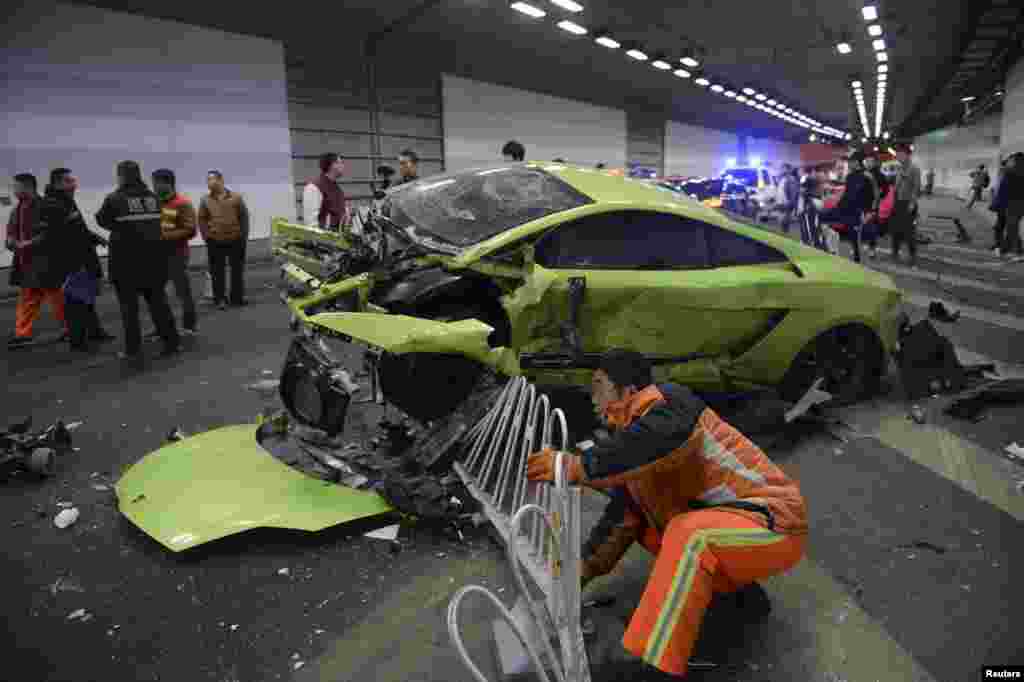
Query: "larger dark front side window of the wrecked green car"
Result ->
[[535, 211, 710, 270]]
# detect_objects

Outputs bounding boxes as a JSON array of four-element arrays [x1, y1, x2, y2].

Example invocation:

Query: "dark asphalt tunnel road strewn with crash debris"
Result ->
[[0, 233, 1024, 682]]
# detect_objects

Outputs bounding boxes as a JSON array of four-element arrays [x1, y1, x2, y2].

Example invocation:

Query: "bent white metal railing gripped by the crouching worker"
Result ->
[[447, 377, 590, 682]]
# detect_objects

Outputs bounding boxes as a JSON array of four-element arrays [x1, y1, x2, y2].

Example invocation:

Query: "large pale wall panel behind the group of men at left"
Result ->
[[0, 0, 295, 266]]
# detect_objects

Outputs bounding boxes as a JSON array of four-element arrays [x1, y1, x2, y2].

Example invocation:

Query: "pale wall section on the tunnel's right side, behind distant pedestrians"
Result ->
[[913, 115, 1002, 198]]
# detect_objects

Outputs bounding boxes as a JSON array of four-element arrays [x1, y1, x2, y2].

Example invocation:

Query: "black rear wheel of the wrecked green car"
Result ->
[[779, 325, 885, 407]]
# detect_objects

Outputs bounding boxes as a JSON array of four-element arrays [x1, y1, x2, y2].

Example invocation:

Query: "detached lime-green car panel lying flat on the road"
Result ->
[[116, 424, 391, 552]]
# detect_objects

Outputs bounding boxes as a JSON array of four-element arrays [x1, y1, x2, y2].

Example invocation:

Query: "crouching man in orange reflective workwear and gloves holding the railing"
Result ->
[[526, 350, 807, 676]]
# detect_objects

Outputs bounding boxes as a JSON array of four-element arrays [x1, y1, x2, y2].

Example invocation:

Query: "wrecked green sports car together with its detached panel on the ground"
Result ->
[[117, 159, 904, 552]]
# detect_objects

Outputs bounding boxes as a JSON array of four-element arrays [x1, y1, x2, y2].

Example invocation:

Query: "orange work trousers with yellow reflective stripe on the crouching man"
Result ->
[[623, 509, 805, 676]]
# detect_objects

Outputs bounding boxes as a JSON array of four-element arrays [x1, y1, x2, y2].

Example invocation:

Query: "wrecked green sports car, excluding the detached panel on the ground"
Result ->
[[273, 164, 901, 421]]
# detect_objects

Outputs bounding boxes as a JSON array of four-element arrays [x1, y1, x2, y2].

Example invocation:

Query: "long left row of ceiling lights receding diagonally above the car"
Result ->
[[510, 0, 850, 139]]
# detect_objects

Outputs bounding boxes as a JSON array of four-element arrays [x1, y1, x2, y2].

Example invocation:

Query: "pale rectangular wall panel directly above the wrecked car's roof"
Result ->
[[442, 74, 627, 172]]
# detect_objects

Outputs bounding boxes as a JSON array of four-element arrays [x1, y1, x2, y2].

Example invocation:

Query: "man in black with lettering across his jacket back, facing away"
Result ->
[[96, 161, 181, 359]]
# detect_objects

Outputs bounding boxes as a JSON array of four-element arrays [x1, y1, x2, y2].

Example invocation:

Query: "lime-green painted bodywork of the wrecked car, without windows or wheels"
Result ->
[[273, 159, 901, 388]]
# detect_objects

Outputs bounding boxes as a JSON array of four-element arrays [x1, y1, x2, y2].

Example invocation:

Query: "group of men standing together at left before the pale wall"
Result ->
[[5, 161, 249, 359]]
